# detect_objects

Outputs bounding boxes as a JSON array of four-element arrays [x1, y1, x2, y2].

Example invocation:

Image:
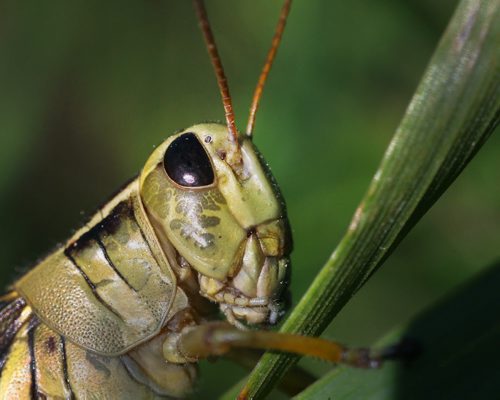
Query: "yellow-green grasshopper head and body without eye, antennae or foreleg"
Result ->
[[0, 124, 290, 399]]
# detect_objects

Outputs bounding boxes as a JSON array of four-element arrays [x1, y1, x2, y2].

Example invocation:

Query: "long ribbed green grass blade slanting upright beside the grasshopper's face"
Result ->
[[242, 0, 500, 399]]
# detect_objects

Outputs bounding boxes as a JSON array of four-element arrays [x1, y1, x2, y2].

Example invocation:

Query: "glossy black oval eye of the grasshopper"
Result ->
[[163, 132, 214, 187]]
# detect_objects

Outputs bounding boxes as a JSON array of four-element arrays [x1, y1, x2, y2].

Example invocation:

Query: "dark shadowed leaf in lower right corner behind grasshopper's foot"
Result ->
[[294, 263, 500, 400]]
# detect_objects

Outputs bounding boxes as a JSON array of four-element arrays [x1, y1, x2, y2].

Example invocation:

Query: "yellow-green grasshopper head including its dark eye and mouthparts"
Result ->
[[140, 124, 291, 324]]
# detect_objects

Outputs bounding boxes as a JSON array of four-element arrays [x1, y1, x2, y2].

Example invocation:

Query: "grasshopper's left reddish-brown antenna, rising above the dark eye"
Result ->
[[193, 0, 241, 148]]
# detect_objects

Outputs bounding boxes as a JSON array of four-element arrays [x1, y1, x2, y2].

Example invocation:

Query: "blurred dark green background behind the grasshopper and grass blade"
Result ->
[[0, 0, 500, 398]]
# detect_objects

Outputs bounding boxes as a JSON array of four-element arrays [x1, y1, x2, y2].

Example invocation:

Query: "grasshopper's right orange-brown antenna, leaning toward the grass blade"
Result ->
[[246, 0, 292, 137]]
